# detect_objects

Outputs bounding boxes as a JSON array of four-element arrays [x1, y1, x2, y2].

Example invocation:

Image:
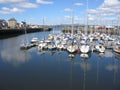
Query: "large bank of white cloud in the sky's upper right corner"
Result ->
[[88, 0, 120, 24]]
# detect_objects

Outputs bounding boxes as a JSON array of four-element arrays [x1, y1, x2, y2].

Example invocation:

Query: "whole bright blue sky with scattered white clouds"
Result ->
[[0, 0, 120, 24]]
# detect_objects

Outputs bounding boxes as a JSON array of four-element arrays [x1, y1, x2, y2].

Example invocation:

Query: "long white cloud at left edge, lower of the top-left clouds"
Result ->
[[0, 7, 24, 14]]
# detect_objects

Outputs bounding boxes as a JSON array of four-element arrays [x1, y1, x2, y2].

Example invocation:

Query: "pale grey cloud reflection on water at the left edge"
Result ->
[[1, 50, 31, 66]]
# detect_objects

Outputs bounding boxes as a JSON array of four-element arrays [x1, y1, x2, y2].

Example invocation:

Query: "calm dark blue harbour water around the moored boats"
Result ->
[[0, 28, 120, 90]]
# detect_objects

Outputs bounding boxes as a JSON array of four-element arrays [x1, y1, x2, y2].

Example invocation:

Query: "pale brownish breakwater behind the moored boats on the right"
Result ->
[[62, 26, 120, 35]]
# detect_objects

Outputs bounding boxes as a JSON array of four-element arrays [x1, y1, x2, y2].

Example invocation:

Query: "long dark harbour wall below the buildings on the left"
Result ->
[[0, 28, 52, 39]]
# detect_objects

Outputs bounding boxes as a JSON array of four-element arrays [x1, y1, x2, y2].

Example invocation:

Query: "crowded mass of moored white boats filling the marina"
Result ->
[[18, 27, 120, 54]]
